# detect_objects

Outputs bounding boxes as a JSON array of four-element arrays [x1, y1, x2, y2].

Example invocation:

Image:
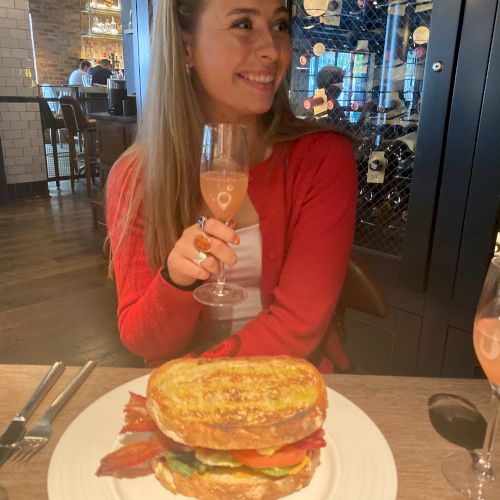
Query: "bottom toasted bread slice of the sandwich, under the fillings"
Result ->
[[152, 451, 320, 500]]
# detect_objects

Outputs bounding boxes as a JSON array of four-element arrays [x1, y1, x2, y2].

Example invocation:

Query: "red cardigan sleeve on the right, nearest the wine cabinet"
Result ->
[[207, 133, 357, 357]]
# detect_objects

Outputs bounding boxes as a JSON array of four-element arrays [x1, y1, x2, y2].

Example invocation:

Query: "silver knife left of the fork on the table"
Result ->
[[0, 361, 64, 467]]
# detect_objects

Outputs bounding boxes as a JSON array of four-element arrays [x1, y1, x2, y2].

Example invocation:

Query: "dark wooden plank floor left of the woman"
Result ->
[[0, 181, 143, 366]]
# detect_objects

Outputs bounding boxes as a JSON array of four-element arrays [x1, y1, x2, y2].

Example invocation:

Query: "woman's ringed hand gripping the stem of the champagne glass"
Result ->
[[167, 218, 239, 286]]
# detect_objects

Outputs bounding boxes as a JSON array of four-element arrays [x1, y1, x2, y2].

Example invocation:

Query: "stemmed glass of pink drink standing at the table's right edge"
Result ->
[[442, 257, 500, 500]]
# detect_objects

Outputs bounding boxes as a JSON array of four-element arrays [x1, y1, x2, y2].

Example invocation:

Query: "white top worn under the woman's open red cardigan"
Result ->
[[210, 224, 262, 337]]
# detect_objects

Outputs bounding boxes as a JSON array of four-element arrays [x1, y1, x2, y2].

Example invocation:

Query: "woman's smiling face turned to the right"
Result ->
[[184, 0, 291, 123]]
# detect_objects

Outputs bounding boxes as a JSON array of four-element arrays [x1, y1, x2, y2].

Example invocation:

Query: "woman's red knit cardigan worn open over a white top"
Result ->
[[107, 132, 357, 371]]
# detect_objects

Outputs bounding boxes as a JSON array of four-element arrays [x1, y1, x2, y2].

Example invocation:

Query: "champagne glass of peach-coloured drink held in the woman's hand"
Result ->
[[194, 123, 252, 307]]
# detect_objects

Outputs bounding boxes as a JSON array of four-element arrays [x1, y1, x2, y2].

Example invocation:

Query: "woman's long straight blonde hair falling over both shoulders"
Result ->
[[108, 0, 342, 274]]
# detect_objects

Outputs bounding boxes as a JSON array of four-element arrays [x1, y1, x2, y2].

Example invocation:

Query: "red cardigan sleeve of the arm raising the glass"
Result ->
[[107, 158, 200, 364]]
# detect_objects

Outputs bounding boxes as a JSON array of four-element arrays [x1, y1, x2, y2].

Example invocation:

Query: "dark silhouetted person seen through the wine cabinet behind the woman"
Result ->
[[316, 66, 376, 135]]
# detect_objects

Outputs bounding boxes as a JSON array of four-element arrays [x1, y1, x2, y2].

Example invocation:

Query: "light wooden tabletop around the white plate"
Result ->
[[0, 365, 500, 500]]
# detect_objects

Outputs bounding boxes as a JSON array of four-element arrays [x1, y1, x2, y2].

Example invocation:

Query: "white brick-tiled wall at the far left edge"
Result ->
[[0, 0, 47, 184]]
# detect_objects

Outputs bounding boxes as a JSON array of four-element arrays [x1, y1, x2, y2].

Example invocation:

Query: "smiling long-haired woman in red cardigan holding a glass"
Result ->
[[107, 0, 356, 371]]
